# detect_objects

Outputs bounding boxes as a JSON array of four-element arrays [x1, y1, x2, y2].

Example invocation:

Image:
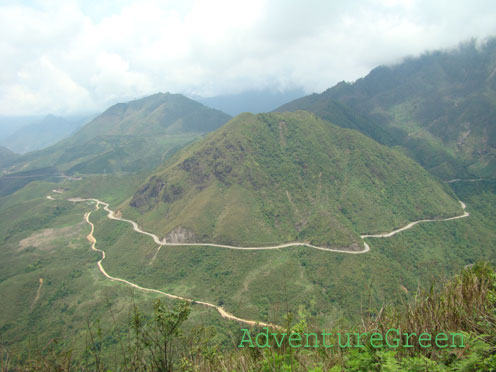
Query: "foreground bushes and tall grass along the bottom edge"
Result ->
[[2, 263, 496, 372]]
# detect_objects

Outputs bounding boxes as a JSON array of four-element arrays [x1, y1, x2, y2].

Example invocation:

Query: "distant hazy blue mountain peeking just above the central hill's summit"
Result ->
[[192, 89, 305, 116]]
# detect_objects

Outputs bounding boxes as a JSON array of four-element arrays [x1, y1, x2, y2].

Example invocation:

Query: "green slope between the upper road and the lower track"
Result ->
[[75, 177, 490, 327]]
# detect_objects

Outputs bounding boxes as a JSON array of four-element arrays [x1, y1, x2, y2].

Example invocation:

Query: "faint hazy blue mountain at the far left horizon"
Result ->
[[2, 115, 87, 154]]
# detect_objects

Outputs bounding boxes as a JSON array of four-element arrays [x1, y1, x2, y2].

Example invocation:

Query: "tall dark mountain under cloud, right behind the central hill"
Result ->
[[277, 38, 496, 178]]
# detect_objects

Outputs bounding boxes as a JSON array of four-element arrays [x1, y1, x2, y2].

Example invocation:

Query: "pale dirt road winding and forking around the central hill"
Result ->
[[51, 198, 470, 329]]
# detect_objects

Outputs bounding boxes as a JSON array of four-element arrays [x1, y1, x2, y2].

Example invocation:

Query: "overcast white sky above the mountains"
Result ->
[[0, 0, 496, 115]]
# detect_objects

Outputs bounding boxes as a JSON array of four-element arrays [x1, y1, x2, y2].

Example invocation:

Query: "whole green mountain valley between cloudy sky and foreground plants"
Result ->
[[0, 35, 496, 371]]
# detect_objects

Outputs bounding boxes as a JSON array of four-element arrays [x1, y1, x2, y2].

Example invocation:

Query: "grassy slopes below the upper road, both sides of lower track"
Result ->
[[0, 176, 496, 366]]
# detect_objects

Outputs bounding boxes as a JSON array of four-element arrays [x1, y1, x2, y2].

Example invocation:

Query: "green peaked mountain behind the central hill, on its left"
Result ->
[[8, 93, 230, 174]]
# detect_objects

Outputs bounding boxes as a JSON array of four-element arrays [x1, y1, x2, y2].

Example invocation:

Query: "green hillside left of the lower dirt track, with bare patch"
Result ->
[[0, 175, 223, 364]]
